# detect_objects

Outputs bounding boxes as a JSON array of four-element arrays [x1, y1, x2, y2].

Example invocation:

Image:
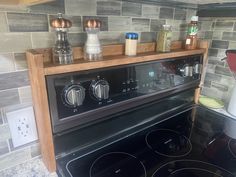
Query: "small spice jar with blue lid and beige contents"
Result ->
[[125, 33, 138, 56]]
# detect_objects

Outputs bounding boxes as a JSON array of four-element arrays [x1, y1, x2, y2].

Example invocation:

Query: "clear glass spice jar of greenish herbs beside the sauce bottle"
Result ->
[[156, 25, 172, 52]]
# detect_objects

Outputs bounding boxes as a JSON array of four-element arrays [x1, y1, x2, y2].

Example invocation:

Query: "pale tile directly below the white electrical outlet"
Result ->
[[0, 148, 31, 171]]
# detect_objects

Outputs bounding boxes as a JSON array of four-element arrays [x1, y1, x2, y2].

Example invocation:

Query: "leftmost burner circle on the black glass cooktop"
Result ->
[[90, 152, 146, 177]]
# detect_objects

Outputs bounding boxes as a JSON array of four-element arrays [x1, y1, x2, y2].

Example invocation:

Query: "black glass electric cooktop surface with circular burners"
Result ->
[[59, 107, 236, 177]]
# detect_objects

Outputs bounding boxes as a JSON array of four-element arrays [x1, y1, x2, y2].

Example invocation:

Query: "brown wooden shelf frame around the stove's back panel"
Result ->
[[27, 40, 209, 172]]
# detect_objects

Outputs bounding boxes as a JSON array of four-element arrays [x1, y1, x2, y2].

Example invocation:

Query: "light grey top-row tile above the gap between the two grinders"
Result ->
[[65, 0, 96, 16]]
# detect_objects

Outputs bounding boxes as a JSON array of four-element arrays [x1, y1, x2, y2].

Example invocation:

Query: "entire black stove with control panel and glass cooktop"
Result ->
[[46, 55, 236, 177]]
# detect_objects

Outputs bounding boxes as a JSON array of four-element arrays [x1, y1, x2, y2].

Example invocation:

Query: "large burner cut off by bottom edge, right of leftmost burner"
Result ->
[[152, 160, 234, 177]]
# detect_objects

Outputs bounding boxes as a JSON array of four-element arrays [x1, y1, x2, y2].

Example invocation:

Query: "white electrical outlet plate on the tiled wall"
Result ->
[[6, 107, 38, 148]]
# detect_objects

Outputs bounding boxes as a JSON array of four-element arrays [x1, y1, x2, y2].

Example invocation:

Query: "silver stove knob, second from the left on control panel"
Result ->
[[91, 79, 110, 101]]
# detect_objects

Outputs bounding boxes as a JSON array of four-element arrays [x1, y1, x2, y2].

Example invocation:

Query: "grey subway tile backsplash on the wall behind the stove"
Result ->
[[0, 0, 197, 176]]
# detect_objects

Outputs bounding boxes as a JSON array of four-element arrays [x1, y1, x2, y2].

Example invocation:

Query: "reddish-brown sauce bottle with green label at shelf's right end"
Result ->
[[185, 16, 198, 50]]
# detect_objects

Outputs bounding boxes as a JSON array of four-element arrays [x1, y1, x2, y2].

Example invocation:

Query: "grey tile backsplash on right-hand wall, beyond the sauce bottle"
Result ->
[[200, 17, 236, 105]]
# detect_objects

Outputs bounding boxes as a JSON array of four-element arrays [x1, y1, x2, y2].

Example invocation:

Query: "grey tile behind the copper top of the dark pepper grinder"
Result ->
[[49, 15, 83, 32]]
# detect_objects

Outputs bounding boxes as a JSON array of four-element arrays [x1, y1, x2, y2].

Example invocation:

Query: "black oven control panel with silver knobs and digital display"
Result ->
[[46, 55, 202, 133]]
